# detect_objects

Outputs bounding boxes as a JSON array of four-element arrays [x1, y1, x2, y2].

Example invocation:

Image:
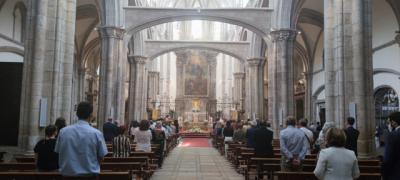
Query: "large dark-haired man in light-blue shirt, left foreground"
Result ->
[[55, 102, 108, 179]]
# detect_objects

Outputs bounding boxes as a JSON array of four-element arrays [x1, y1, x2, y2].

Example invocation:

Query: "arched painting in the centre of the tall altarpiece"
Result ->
[[184, 51, 208, 96]]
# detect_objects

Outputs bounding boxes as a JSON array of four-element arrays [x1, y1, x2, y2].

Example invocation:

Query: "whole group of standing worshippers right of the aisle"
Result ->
[[213, 112, 400, 180]]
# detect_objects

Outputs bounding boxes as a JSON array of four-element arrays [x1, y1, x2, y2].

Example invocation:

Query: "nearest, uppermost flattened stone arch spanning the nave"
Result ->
[[125, 7, 272, 40]]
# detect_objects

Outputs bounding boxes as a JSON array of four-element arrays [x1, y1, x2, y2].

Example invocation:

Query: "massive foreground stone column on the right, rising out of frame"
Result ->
[[324, 0, 375, 157]]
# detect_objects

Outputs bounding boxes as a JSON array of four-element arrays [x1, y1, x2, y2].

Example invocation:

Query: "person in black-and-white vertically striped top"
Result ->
[[112, 126, 131, 157]]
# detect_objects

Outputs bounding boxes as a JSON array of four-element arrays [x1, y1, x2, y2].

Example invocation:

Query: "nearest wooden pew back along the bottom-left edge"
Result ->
[[0, 171, 132, 180]]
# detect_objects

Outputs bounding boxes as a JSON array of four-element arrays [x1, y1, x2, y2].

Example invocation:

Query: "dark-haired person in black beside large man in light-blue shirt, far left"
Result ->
[[34, 125, 58, 171]]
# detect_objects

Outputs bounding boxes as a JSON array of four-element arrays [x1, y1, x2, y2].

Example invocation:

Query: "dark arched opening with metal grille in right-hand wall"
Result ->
[[374, 87, 399, 125]]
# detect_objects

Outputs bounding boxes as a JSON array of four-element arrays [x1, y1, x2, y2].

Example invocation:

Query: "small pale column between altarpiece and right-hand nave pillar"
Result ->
[[233, 72, 245, 111]]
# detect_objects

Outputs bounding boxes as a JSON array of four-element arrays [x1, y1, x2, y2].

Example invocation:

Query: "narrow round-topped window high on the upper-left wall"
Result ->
[[13, 2, 26, 42]]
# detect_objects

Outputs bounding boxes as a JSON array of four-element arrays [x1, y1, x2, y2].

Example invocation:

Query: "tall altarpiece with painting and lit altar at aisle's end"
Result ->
[[175, 50, 218, 133]]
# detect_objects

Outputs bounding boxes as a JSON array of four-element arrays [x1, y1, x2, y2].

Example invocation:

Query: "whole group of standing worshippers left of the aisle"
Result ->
[[34, 102, 180, 179]]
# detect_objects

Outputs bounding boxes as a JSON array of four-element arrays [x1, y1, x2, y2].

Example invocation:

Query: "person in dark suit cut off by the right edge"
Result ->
[[382, 112, 400, 180]]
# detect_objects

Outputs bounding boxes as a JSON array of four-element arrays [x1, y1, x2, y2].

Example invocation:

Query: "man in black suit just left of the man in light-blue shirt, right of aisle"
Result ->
[[253, 121, 274, 157]]
